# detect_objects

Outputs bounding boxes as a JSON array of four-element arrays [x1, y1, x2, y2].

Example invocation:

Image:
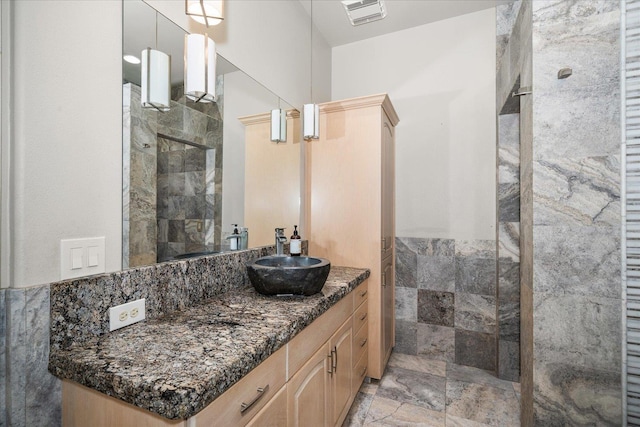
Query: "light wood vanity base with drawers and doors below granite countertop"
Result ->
[[63, 280, 368, 427]]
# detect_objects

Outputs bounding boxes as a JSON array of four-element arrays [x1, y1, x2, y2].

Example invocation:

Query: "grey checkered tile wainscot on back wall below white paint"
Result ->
[[395, 237, 496, 371]]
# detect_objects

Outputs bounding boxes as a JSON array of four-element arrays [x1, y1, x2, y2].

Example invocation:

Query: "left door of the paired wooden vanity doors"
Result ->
[[287, 342, 331, 427]]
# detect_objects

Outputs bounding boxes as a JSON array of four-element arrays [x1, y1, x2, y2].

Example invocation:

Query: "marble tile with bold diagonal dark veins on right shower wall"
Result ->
[[533, 156, 620, 227]]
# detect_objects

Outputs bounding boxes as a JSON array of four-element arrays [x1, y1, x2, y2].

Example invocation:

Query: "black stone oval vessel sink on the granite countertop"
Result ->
[[247, 255, 331, 295]]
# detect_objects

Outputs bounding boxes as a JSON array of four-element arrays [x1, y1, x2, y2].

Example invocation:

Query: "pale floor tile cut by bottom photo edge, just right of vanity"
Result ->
[[364, 396, 445, 427]]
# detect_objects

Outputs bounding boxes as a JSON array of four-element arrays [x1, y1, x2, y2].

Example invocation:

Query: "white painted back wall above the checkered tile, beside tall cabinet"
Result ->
[[332, 9, 496, 239]]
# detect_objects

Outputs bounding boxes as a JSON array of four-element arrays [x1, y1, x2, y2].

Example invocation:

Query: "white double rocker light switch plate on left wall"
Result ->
[[60, 237, 106, 280]]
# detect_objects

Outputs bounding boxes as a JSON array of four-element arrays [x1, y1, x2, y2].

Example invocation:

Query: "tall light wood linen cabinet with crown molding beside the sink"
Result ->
[[303, 94, 399, 379]]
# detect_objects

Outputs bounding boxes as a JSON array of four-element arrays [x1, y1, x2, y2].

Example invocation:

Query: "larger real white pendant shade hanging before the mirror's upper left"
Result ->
[[184, 34, 216, 102]]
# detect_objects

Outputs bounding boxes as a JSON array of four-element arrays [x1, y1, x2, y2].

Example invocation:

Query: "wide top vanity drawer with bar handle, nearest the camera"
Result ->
[[190, 347, 287, 427]]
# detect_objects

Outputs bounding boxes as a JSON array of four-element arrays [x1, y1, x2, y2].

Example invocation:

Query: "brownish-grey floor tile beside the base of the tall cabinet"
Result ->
[[376, 366, 446, 411]]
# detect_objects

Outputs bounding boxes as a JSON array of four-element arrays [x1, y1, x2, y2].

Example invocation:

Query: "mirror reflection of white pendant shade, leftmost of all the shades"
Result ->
[[141, 48, 171, 111]]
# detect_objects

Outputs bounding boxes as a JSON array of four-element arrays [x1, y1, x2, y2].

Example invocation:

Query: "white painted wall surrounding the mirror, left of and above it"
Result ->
[[1, 0, 331, 287]]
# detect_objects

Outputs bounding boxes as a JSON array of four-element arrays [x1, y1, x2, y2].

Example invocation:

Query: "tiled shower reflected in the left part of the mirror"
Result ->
[[122, 80, 224, 268]]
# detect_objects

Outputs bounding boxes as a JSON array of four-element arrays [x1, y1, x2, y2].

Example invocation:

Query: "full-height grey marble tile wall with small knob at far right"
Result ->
[[532, 0, 622, 426]]
